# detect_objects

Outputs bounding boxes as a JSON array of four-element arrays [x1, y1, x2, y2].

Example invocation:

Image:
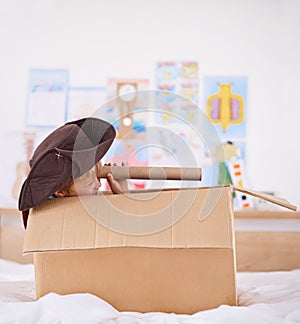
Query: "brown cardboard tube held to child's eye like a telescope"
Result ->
[[98, 165, 202, 181]]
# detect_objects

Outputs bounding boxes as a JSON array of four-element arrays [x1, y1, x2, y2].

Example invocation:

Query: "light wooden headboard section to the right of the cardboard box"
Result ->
[[235, 210, 300, 271]]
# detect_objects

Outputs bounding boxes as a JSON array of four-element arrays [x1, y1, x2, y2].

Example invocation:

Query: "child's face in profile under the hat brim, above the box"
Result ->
[[68, 167, 101, 196]]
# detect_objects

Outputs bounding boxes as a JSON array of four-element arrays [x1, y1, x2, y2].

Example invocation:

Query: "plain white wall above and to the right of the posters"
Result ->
[[0, 0, 300, 206]]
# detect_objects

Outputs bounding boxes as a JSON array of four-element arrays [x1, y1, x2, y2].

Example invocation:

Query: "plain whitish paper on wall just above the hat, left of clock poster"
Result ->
[[66, 87, 107, 121]]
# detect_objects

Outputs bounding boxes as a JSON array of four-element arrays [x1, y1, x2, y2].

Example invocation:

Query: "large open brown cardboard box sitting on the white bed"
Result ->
[[24, 186, 296, 314]]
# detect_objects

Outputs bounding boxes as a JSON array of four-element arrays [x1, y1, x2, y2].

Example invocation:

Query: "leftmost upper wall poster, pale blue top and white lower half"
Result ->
[[26, 69, 69, 128]]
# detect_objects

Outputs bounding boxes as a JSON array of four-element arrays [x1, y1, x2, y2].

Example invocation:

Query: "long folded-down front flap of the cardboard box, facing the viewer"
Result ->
[[23, 187, 234, 252]]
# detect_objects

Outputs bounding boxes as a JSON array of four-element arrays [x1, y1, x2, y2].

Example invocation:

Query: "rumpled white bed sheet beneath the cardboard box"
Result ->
[[0, 259, 300, 324]]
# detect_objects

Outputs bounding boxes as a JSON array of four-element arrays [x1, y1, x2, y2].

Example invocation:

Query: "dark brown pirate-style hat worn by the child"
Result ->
[[19, 117, 116, 227]]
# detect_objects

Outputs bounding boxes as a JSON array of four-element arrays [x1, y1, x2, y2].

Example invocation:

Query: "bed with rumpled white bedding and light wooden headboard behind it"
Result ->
[[0, 209, 300, 323]]
